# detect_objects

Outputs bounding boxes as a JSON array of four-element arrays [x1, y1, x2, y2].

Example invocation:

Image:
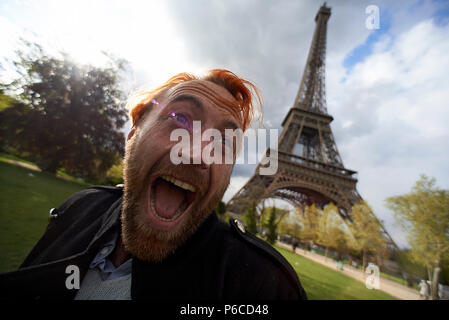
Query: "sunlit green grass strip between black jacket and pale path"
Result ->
[[275, 246, 396, 300]]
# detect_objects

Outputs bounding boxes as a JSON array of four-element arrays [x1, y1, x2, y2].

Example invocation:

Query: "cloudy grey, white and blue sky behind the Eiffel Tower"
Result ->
[[0, 0, 449, 247]]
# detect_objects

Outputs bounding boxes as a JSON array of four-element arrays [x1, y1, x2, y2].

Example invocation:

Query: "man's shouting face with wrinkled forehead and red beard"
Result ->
[[121, 80, 240, 261]]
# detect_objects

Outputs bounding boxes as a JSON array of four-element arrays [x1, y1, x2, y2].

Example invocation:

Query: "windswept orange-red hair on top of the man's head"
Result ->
[[128, 69, 263, 131]]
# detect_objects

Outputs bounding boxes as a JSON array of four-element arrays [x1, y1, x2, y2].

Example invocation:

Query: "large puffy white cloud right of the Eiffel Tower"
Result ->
[[328, 20, 449, 245]]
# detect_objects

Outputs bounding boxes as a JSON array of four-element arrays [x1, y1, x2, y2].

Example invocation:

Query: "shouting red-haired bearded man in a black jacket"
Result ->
[[0, 70, 306, 300]]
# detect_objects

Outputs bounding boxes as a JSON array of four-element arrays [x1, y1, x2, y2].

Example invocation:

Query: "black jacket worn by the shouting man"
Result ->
[[0, 187, 306, 300]]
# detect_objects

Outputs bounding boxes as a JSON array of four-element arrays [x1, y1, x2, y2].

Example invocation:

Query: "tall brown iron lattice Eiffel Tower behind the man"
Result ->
[[227, 3, 397, 248]]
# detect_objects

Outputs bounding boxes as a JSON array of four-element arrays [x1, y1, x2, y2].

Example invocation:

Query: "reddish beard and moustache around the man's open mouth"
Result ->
[[121, 139, 229, 262]]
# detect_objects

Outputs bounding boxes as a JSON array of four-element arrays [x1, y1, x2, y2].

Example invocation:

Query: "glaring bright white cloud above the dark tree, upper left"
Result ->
[[0, 0, 202, 87]]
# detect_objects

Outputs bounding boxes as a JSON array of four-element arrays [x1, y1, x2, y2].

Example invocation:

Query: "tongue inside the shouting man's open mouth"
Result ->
[[154, 179, 186, 219]]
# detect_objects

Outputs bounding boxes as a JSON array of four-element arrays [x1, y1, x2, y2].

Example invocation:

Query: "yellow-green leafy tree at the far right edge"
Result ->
[[385, 175, 449, 299]]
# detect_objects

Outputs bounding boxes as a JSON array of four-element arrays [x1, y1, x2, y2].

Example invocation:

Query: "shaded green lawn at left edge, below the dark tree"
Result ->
[[0, 158, 87, 272]]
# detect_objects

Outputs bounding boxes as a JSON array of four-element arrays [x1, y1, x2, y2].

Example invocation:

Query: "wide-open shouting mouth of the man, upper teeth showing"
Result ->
[[149, 176, 196, 223]]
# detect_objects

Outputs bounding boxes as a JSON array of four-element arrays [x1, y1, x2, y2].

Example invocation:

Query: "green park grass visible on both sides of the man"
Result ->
[[0, 158, 396, 300]]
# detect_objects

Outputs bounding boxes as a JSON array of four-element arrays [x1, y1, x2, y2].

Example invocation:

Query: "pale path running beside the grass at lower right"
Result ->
[[277, 242, 421, 300]]
